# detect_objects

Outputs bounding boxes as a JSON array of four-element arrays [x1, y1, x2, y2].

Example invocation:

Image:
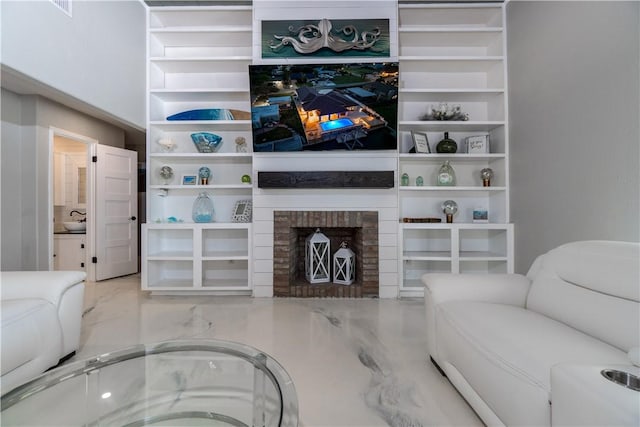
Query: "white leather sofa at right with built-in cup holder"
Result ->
[[422, 241, 640, 426]]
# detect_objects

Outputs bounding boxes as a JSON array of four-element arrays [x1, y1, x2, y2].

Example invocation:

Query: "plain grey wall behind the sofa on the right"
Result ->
[[507, 1, 640, 272]]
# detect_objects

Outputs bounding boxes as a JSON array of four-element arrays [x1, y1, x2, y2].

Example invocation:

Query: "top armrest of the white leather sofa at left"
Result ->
[[0, 271, 87, 307]]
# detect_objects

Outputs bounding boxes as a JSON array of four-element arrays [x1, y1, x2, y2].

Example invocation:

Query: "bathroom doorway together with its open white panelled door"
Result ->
[[49, 128, 138, 281]]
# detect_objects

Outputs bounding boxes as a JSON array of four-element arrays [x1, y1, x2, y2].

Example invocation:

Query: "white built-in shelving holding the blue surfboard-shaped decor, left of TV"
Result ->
[[142, 6, 252, 294]]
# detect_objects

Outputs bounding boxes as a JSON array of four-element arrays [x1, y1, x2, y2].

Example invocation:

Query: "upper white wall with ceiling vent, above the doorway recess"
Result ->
[[0, 0, 146, 129]]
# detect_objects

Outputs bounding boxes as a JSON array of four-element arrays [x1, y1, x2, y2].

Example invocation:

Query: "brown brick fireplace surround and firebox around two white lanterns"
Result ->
[[273, 211, 379, 298]]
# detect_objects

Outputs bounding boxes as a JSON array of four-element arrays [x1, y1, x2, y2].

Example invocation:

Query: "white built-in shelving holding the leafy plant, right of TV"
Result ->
[[398, 3, 513, 296]]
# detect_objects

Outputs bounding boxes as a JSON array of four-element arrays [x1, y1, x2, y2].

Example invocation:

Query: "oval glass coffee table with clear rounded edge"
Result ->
[[2, 340, 298, 427]]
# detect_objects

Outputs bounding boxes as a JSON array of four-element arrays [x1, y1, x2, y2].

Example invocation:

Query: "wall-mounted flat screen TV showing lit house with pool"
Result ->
[[249, 62, 398, 152]]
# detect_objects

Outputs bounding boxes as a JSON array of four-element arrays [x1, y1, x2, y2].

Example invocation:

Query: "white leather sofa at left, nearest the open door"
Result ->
[[0, 271, 86, 394]]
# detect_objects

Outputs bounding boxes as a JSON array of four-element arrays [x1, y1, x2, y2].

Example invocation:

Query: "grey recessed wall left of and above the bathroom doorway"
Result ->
[[0, 88, 125, 270]]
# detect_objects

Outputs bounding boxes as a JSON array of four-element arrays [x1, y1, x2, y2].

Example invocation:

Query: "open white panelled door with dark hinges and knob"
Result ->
[[93, 144, 138, 280]]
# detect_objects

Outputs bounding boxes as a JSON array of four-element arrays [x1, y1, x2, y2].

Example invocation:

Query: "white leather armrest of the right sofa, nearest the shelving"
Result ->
[[422, 273, 531, 307]]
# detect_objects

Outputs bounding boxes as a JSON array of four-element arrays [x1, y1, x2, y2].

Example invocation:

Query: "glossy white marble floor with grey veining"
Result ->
[[71, 275, 482, 427]]
